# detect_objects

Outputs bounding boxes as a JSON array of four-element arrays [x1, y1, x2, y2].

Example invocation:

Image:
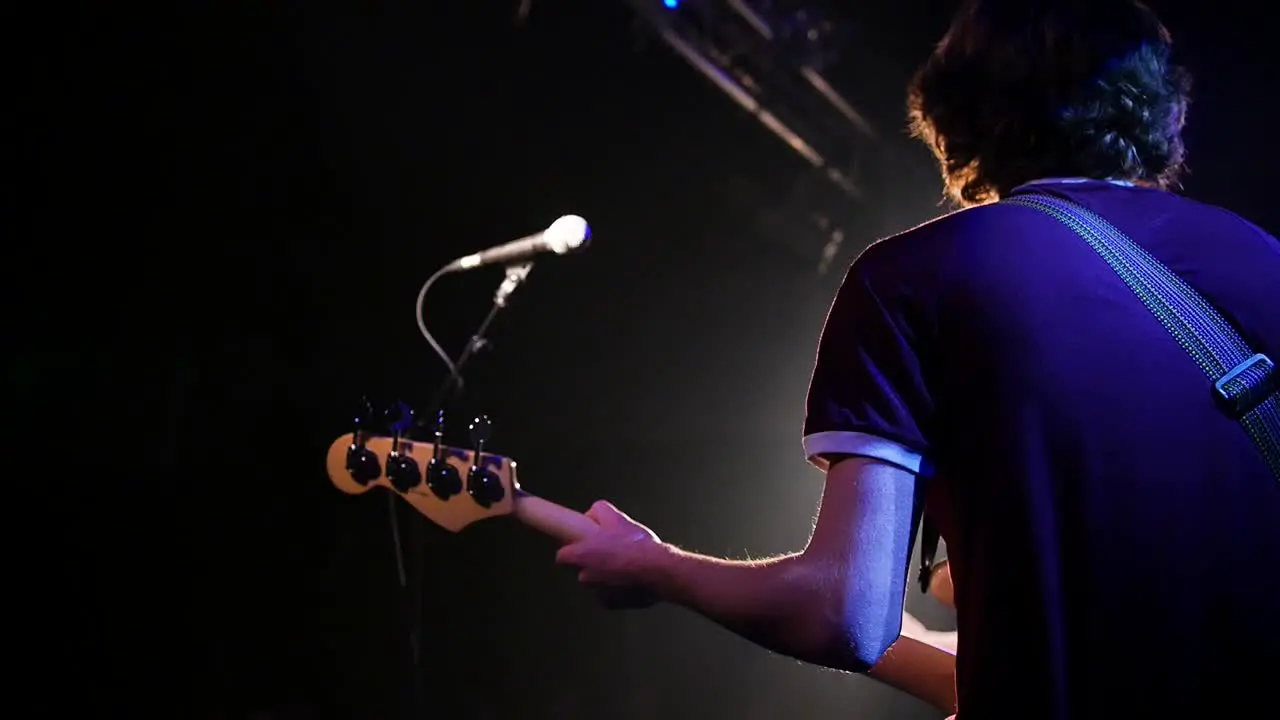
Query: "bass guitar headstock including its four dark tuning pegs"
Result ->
[[325, 416, 520, 533]]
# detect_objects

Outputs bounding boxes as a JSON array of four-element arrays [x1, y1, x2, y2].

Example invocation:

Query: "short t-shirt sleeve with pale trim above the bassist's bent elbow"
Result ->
[[804, 259, 933, 474]]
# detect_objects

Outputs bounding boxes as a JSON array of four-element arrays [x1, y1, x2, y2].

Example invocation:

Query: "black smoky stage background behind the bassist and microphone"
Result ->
[[12, 0, 1280, 719]]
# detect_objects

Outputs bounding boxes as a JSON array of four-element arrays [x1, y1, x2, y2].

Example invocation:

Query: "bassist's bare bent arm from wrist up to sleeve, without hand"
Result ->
[[629, 457, 915, 673]]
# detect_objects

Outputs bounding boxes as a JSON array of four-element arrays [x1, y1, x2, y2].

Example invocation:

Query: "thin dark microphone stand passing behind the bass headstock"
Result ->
[[387, 263, 534, 719]]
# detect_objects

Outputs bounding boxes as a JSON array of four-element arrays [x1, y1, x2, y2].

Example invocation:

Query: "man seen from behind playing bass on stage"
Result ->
[[558, 0, 1280, 720]]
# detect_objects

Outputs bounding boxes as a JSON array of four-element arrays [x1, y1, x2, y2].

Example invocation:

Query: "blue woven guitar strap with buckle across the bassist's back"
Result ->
[[920, 193, 1280, 592]]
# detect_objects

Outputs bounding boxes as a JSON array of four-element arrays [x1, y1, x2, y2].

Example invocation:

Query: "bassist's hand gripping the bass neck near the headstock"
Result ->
[[556, 500, 664, 607]]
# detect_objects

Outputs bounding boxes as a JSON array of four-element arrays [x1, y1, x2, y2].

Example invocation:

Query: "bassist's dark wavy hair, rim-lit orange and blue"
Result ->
[[908, 0, 1190, 205]]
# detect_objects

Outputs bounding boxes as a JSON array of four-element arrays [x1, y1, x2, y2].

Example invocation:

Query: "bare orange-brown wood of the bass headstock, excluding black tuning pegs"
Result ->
[[325, 433, 520, 533]]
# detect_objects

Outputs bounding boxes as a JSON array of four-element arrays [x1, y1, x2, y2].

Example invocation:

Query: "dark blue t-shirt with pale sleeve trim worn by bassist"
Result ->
[[804, 181, 1280, 720]]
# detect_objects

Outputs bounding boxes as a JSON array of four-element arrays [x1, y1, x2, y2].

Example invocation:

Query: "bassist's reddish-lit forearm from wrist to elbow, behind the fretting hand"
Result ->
[[648, 546, 874, 673]]
